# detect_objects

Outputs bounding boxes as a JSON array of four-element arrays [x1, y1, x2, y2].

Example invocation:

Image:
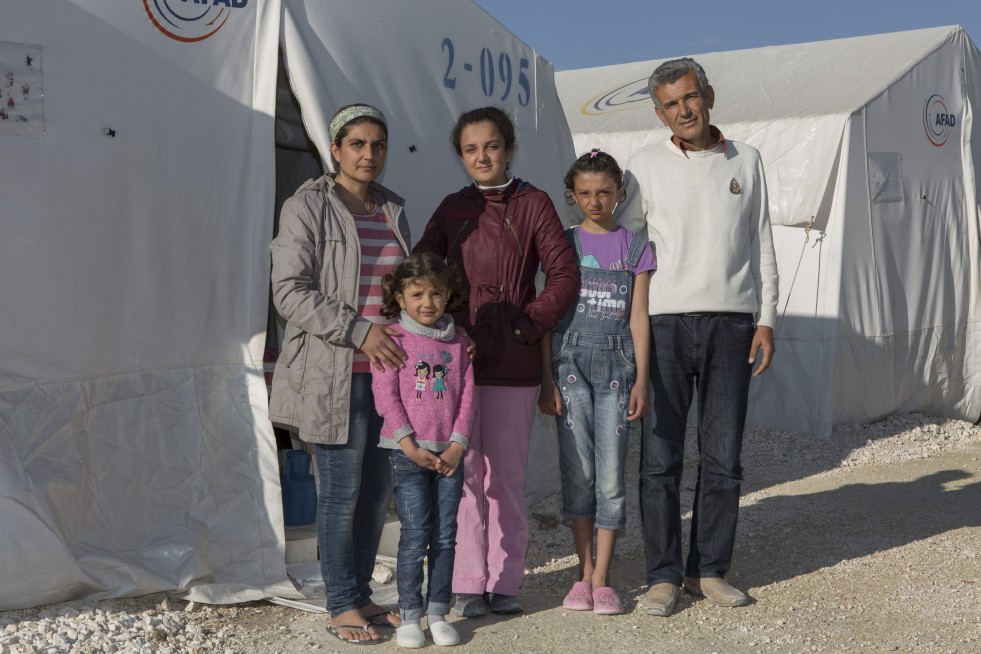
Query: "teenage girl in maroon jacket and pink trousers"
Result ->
[[414, 107, 579, 617]]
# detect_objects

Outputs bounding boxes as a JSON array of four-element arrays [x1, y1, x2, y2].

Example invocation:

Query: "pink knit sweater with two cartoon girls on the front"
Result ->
[[371, 311, 477, 453]]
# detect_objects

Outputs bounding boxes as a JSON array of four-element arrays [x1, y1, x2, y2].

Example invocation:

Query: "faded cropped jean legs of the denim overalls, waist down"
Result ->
[[552, 331, 637, 531]]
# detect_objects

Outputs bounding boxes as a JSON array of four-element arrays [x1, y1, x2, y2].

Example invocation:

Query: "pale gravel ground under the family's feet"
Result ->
[[0, 415, 981, 654]]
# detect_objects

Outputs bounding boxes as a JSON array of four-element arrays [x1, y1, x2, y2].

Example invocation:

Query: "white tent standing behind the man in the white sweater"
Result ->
[[556, 27, 981, 435]]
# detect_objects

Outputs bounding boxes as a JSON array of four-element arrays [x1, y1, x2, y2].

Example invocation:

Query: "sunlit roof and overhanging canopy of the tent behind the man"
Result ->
[[556, 28, 950, 225]]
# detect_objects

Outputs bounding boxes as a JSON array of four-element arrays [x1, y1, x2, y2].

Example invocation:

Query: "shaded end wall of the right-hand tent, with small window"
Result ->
[[835, 39, 977, 430]]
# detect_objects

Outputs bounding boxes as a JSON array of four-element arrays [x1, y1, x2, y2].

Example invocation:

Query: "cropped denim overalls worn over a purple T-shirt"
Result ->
[[552, 228, 648, 531]]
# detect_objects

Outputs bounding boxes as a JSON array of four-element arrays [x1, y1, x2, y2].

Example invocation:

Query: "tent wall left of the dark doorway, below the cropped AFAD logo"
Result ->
[[0, 0, 292, 609]]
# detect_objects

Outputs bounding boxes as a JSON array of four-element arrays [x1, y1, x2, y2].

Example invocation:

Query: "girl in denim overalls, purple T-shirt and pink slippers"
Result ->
[[538, 150, 656, 615]]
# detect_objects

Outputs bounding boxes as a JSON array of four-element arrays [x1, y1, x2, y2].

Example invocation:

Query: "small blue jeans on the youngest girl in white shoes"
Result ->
[[391, 450, 463, 620]]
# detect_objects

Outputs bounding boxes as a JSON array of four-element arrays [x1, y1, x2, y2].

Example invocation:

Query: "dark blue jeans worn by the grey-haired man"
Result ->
[[640, 313, 755, 584]]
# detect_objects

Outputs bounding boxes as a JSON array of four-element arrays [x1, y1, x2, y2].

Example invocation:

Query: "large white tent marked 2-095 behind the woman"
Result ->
[[0, 0, 572, 610]]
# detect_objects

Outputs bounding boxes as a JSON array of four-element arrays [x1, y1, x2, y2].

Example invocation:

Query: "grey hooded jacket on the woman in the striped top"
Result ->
[[269, 175, 410, 445]]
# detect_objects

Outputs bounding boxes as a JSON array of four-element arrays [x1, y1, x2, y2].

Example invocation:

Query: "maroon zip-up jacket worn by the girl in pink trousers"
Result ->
[[413, 178, 579, 386]]
